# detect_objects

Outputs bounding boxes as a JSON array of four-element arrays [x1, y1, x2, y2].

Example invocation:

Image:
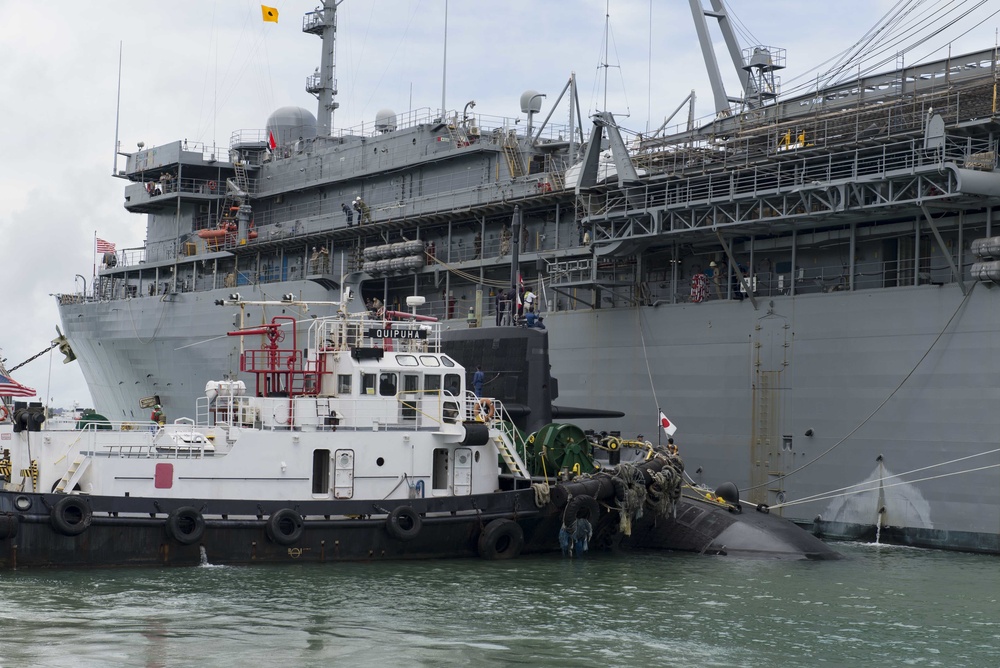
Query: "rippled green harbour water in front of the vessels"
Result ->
[[0, 544, 1000, 667]]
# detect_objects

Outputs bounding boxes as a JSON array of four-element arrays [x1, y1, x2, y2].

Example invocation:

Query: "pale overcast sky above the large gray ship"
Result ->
[[0, 0, 1000, 407]]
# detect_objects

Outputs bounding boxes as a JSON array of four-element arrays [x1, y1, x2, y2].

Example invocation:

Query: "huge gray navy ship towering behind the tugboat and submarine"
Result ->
[[58, 0, 1000, 553]]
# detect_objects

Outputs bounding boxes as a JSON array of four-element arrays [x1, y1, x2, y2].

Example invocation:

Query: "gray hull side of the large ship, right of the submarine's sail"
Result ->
[[546, 286, 1000, 552]]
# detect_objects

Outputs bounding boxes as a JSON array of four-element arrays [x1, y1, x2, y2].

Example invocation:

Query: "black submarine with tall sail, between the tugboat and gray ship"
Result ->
[[442, 326, 842, 560]]
